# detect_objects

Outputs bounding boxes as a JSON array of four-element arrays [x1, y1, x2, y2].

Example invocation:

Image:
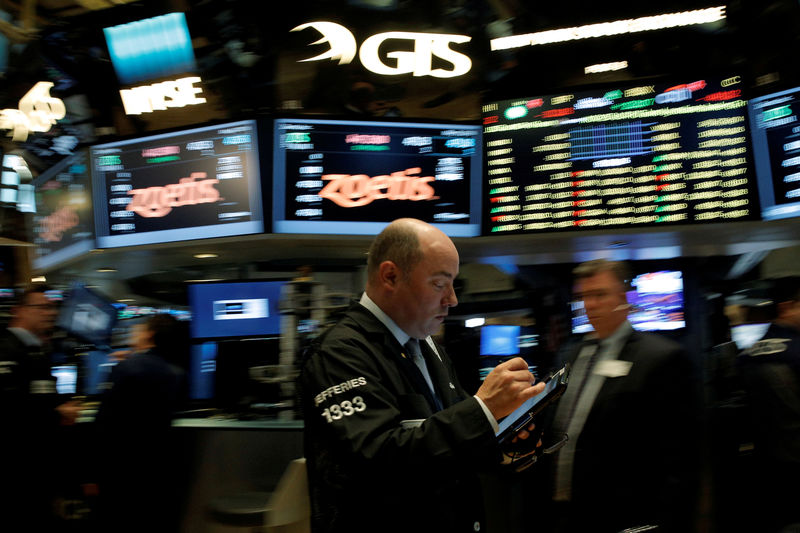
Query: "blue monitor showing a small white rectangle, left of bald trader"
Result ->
[[188, 281, 286, 339]]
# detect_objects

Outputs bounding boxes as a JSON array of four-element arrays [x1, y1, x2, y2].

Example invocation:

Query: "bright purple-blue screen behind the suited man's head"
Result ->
[[572, 270, 686, 333]]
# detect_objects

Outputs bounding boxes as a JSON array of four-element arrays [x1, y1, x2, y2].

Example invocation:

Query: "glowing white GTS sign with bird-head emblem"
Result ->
[[291, 22, 472, 78]]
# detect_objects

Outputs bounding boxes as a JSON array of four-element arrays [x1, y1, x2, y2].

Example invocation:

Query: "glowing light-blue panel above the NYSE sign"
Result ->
[[103, 13, 195, 84]]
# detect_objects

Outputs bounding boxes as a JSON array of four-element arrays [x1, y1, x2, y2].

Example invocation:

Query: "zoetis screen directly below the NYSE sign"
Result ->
[[91, 120, 264, 248]]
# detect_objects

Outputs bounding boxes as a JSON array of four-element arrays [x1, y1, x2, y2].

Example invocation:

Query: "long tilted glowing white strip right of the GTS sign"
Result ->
[[490, 6, 725, 50]]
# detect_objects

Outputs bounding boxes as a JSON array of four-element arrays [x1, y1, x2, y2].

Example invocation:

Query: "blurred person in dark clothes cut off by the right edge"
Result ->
[[737, 276, 800, 533]]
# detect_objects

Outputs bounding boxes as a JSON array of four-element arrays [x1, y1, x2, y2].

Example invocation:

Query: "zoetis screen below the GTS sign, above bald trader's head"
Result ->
[[272, 118, 481, 237]]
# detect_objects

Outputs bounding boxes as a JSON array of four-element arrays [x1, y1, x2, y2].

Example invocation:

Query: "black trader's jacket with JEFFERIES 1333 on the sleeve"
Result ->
[[299, 305, 500, 533]]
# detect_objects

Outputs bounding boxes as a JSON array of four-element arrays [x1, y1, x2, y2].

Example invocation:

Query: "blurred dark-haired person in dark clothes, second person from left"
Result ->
[[95, 314, 189, 531]]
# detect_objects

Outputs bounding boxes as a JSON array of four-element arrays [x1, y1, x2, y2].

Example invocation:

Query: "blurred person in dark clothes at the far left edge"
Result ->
[[0, 285, 80, 530]]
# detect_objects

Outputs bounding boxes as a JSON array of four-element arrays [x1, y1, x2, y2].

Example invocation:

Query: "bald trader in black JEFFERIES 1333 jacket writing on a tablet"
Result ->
[[300, 219, 544, 533]]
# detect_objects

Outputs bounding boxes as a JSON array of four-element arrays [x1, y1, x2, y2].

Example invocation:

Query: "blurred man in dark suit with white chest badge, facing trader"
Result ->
[[545, 259, 700, 533]]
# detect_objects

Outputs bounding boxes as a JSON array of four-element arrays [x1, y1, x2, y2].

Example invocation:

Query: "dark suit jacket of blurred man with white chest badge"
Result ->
[[548, 331, 701, 533]]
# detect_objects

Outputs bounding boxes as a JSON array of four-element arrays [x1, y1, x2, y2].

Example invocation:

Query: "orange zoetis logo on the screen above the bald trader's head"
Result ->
[[319, 167, 439, 207]]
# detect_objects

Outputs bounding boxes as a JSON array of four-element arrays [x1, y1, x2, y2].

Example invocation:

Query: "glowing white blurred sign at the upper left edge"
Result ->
[[0, 81, 67, 142]]
